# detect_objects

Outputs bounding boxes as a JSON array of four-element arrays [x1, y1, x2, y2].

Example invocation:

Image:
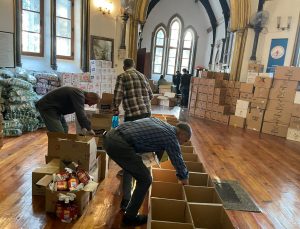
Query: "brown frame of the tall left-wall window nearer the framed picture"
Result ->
[[55, 0, 75, 60]]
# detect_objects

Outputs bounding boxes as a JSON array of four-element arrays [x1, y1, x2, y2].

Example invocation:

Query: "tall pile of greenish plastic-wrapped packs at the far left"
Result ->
[[0, 68, 43, 136]]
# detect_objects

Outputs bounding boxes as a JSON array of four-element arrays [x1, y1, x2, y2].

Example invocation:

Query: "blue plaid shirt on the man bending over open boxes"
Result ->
[[117, 118, 189, 180]]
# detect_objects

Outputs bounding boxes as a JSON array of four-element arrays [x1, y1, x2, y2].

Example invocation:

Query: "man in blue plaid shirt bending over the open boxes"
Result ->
[[103, 118, 192, 225]]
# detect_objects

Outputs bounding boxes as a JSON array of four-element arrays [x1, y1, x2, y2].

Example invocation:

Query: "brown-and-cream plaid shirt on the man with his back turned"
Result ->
[[114, 68, 153, 117]]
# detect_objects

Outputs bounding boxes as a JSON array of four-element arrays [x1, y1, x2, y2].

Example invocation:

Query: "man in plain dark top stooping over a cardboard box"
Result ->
[[36, 87, 100, 135]]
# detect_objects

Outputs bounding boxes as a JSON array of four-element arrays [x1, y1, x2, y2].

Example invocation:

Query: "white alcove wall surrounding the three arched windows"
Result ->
[[142, 0, 211, 80]]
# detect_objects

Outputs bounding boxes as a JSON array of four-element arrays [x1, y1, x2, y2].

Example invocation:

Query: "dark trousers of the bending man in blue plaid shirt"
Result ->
[[103, 129, 152, 216]]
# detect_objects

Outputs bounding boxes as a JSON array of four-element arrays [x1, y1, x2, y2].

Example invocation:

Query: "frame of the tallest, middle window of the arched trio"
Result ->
[[164, 17, 182, 75]]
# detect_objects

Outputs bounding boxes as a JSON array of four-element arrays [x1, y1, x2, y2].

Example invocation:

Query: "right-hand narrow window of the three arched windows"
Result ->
[[181, 30, 195, 71]]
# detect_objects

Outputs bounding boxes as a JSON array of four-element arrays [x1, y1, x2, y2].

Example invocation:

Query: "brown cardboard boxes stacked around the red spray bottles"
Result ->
[[32, 132, 103, 215]]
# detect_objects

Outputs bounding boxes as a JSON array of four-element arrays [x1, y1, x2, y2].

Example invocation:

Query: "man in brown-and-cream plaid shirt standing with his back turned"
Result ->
[[113, 59, 153, 211]]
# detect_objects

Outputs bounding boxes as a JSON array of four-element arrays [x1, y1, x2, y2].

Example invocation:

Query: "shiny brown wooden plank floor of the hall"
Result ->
[[0, 106, 300, 229]]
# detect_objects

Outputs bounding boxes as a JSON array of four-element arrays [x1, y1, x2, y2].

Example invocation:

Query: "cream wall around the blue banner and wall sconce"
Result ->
[[240, 0, 300, 81]]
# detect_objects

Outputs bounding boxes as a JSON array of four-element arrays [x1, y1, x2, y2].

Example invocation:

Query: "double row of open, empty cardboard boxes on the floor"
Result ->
[[147, 115, 234, 229]]
